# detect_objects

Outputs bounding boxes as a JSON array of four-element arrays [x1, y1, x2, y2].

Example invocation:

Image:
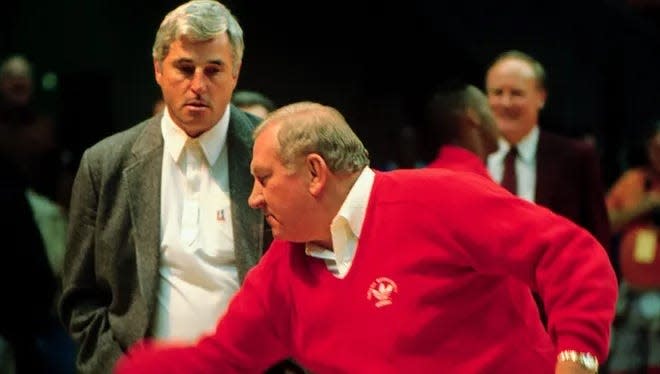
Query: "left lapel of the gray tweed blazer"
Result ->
[[124, 116, 163, 315]]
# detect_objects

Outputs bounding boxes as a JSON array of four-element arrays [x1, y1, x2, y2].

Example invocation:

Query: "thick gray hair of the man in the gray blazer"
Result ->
[[151, 0, 245, 72]]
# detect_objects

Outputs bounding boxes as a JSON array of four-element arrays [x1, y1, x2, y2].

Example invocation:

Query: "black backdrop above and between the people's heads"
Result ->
[[0, 0, 660, 185]]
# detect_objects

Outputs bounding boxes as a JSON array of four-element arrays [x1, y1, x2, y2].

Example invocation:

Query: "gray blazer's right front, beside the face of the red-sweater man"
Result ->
[[227, 106, 264, 282]]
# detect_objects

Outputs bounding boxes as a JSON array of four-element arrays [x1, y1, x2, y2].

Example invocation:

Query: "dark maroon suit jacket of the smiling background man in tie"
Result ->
[[535, 131, 611, 248]]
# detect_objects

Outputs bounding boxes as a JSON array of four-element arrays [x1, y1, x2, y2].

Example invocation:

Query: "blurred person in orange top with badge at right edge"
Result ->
[[606, 121, 660, 374]]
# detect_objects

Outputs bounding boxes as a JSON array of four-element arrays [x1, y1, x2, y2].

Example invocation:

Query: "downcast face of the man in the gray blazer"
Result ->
[[154, 34, 238, 137]]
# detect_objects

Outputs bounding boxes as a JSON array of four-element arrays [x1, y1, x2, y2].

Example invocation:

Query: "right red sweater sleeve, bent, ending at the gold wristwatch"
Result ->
[[440, 176, 617, 360]]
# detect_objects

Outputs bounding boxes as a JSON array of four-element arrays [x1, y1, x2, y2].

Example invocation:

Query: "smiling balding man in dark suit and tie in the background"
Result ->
[[486, 50, 610, 320]]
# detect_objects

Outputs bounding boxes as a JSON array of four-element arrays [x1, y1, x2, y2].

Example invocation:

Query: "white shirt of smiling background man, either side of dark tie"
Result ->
[[488, 126, 539, 202]]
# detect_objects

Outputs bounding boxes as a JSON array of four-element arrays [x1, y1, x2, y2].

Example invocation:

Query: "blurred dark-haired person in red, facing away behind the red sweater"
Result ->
[[427, 83, 499, 179]]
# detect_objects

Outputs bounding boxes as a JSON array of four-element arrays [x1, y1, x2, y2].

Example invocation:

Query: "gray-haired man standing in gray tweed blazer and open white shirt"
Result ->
[[59, 0, 269, 373]]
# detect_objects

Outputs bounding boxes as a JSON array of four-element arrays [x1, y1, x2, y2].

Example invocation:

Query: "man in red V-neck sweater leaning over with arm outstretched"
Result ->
[[117, 103, 617, 374]]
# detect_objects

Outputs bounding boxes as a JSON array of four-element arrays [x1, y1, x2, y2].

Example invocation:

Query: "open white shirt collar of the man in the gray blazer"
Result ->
[[160, 105, 230, 166]]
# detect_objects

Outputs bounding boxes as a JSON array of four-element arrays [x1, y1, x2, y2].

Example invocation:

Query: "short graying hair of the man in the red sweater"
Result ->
[[254, 102, 369, 173]]
